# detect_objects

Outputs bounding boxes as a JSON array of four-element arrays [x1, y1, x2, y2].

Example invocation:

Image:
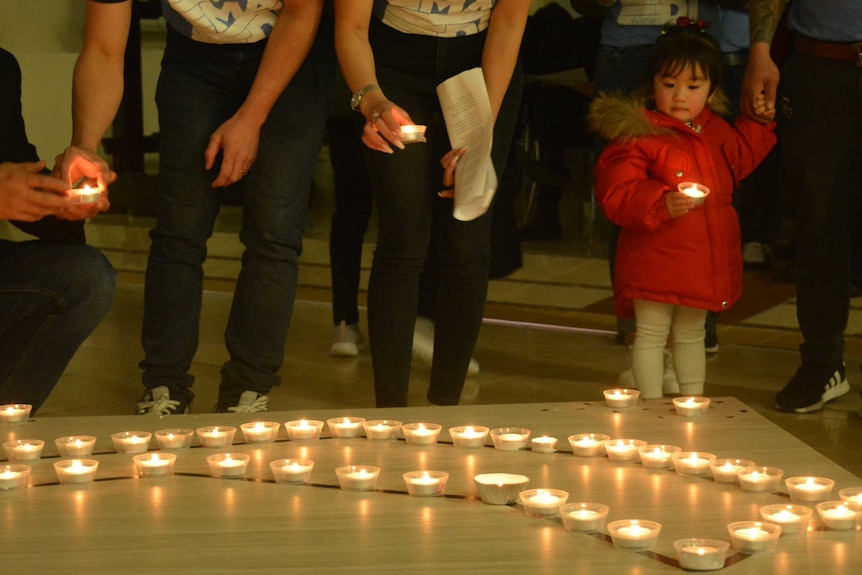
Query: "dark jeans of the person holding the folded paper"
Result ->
[[365, 20, 520, 407]]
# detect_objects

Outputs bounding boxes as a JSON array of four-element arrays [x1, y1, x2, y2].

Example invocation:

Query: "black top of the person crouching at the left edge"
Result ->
[[0, 48, 84, 244]]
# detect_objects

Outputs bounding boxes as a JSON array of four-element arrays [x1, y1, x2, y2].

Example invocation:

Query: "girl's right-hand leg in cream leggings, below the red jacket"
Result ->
[[671, 306, 706, 395]]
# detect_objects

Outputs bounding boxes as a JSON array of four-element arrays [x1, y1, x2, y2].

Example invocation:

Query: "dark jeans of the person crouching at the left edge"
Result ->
[[0, 241, 116, 413]]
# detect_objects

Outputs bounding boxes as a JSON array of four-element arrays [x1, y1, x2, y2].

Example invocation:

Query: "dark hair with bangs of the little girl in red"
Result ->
[[645, 18, 723, 95]]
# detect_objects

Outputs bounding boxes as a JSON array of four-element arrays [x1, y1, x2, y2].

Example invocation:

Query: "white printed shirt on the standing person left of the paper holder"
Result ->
[[167, 0, 284, 44]]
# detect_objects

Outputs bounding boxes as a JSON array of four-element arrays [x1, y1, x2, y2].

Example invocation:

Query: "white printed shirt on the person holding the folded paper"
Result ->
[[376, 0, 495, 38]]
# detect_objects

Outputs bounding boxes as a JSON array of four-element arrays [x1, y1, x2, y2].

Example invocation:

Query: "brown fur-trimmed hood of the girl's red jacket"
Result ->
[[587, 88, 730, 140]]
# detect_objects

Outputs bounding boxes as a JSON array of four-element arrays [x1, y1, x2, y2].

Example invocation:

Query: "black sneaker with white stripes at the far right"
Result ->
[[775, 363, 850, 413]]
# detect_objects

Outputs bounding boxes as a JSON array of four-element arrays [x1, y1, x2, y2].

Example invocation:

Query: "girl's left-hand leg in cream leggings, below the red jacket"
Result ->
[[632, 300, 673, 399]]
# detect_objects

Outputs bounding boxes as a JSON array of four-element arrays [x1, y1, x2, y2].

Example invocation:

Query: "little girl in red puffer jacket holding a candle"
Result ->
[[590, 22, 775, 399]]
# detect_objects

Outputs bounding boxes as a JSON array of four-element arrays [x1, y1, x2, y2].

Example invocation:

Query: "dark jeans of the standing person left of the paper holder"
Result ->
[[141, 22, 334, 404]]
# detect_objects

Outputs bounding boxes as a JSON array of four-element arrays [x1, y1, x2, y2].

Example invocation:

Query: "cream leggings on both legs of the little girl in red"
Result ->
[[632, 299, 706, 399]]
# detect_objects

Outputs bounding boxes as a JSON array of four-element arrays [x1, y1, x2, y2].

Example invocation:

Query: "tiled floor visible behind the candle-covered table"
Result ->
[[0, 154, 862, 477]]
